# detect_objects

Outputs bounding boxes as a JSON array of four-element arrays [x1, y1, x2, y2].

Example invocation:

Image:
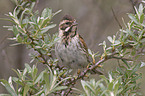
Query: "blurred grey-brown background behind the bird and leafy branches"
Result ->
[[0, 0, 145, 96]]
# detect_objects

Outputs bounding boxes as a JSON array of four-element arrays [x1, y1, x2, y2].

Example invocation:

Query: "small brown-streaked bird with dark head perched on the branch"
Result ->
[[55, 15, 102, 75]]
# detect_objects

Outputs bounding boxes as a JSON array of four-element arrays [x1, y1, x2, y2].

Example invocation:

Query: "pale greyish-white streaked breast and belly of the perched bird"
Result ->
[[55, 36, 88, 68]]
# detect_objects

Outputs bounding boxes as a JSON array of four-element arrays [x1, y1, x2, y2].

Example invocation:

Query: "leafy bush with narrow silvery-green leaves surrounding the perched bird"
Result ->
[[0, 0, 145, 96]]
